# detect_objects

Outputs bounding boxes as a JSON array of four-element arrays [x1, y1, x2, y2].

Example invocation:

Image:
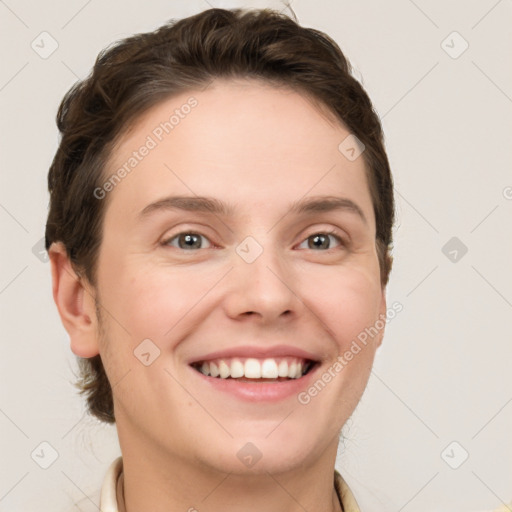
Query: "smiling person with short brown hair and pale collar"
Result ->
[[46, 9, 394, 512]]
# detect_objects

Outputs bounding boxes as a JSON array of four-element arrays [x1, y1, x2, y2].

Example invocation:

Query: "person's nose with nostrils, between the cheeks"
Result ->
[[224, 240, 301, 324]]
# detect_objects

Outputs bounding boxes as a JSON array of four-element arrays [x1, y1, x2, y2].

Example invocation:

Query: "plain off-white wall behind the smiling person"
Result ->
[[0, 0, 512, 512]]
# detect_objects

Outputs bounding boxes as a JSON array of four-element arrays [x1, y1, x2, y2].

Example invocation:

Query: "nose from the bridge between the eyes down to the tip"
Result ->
[[228, 233, 297, 320]]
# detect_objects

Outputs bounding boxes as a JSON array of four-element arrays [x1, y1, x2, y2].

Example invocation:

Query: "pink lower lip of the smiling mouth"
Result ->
[[191, 363, 320, 402]]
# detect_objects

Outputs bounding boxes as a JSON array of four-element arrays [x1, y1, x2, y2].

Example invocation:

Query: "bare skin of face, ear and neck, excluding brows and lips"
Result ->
[[50, 80, 386, 512]]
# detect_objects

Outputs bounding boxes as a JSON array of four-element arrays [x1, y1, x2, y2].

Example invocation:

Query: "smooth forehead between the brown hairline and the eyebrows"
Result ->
[[102, 76, 371, 226]]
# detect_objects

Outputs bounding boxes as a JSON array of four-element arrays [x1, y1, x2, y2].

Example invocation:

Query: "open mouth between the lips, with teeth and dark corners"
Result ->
[[190, 356, 319, 383]]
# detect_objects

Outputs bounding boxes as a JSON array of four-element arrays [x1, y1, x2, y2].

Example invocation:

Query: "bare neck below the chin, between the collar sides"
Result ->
[[116, 424, 342, 512]]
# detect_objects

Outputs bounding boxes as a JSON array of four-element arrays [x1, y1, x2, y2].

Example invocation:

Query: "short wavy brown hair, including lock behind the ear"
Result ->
[[46, 9, 394, 423]]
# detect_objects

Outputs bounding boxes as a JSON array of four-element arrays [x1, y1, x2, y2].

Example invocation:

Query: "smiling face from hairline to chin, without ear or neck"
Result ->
[[88, 81, 386, 473]]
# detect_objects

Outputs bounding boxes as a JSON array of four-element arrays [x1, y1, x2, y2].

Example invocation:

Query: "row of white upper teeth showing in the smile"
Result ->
[[198, 357, 308, 379]]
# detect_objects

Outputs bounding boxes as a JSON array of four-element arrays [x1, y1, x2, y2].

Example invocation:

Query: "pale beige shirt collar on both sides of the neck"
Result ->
[[100, 456, 360, 512]]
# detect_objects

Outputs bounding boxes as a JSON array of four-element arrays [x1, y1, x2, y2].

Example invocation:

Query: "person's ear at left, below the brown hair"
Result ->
[[48, 242, 99, 358]]
